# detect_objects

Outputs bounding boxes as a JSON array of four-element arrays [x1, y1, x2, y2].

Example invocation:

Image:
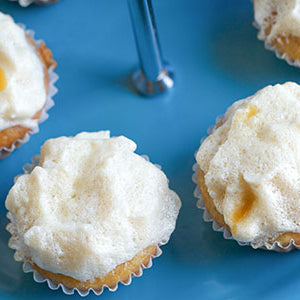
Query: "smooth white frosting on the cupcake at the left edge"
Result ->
[[0, 12, 47, 131]]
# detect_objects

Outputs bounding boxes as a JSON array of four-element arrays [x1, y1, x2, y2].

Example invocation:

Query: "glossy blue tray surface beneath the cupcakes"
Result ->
[[0, 0, 300, 300]]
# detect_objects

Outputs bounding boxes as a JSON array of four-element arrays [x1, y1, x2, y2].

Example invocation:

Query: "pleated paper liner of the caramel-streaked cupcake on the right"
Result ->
[[192, 120, 300, 252]]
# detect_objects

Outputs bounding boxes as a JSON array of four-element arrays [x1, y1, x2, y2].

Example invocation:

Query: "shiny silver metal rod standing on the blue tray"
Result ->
[[128, 0, 174, 96]]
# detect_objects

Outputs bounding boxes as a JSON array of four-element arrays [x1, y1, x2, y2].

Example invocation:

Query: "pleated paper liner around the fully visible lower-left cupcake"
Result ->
[[6, 155, 168, 296]]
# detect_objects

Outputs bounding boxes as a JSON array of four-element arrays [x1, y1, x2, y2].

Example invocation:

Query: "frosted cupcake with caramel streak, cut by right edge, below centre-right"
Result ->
[[196, 82, 300, 251]]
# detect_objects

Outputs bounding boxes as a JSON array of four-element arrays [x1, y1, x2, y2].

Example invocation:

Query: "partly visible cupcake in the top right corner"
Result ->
[[253, 0, 300, 67]]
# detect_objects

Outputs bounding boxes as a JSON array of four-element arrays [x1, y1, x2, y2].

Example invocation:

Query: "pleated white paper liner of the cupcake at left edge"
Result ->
[[0, 24, 59, 159]]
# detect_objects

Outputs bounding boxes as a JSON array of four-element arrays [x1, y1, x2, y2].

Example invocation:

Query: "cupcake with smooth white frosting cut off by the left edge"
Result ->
[[0, 12, 56, 158]]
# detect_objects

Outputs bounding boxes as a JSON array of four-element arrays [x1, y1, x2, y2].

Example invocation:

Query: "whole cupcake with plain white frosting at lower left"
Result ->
[[6, 131, 181, 294]]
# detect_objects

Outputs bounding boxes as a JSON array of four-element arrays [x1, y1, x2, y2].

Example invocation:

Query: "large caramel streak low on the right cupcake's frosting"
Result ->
[[232, 177, 256, 234]]
